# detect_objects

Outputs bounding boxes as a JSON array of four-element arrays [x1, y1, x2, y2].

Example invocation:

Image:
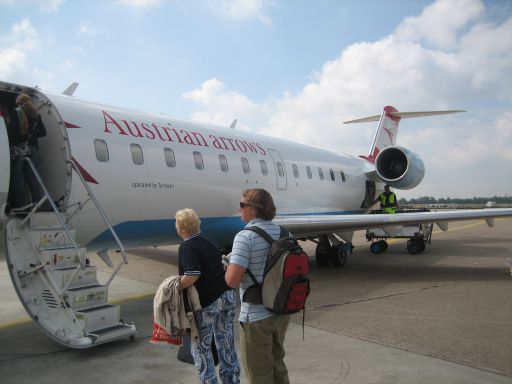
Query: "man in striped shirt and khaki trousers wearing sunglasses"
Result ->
[[225, 189, 309, 384]]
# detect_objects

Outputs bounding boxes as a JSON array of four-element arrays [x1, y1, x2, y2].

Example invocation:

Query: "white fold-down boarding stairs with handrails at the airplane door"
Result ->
[[5, 158, 137, 348]]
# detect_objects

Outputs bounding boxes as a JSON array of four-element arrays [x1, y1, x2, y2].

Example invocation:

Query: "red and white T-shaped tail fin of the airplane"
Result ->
[[343, 106, 465, 163]]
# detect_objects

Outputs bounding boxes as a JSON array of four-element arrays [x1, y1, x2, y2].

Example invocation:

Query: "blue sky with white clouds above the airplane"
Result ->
[[0, 0, 512, 198]]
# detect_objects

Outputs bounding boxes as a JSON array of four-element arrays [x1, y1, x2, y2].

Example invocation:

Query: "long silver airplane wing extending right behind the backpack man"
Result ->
[[274, 208, 512, 237]]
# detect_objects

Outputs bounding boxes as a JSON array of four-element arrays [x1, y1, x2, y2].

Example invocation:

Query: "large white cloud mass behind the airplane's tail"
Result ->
[[189, 0, 512, 196]]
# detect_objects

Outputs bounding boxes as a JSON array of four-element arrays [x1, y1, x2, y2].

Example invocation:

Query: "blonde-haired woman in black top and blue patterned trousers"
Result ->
[[175, 208, 240, 384]]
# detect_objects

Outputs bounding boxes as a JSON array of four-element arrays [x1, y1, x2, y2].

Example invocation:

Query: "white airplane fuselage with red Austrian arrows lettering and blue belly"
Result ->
[[0, 83, 374, 249]]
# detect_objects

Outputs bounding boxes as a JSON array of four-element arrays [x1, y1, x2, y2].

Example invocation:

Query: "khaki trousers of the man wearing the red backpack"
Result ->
[[240, 315, 290, 384]]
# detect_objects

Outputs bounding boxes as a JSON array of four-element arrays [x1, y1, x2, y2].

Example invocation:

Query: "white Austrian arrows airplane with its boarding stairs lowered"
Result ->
[[0, 82, 512, 348]]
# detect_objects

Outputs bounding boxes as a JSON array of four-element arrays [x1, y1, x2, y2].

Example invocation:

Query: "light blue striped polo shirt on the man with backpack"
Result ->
[[229, 218, 281, 323]]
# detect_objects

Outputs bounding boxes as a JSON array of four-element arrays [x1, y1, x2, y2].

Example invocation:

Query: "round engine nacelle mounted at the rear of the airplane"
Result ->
[[375, 146, 425, 189]]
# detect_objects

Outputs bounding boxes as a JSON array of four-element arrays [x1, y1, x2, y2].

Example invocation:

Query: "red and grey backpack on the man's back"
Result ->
[[243, 226, 309, 314]]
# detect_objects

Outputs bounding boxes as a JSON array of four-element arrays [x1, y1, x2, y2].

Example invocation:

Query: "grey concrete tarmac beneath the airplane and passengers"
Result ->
[[0, 219, 512, 384]]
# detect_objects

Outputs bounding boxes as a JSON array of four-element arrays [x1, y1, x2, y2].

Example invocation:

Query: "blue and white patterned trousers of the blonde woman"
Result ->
[[191, 289, 240, 384]]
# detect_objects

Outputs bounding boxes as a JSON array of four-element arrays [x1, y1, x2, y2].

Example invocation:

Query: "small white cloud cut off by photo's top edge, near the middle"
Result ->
[[208, 0, 273, 24]]
